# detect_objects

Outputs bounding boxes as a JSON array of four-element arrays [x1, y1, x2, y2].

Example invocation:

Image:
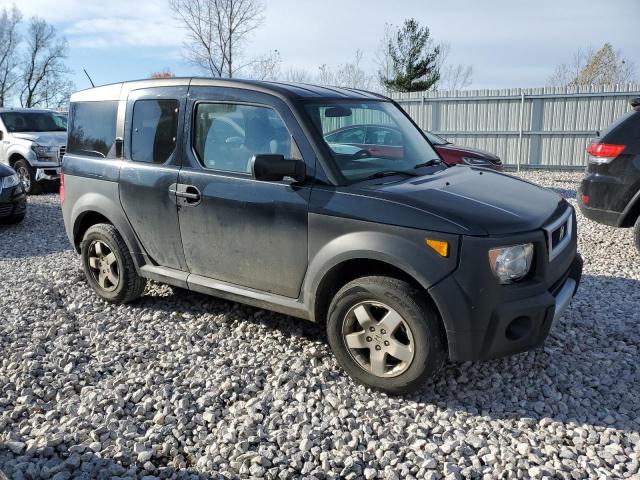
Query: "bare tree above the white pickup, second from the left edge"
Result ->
[[20, 17, 69, 107]]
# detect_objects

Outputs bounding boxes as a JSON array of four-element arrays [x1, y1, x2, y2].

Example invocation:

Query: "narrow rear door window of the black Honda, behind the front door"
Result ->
[[131, 100, 179, 163]]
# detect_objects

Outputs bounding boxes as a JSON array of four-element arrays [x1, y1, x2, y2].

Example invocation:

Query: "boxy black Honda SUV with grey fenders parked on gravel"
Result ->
[[61, 78, 582, 393]]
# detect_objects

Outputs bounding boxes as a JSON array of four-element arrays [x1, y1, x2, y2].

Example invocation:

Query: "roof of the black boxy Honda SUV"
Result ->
[[71, 77, 387, 101]]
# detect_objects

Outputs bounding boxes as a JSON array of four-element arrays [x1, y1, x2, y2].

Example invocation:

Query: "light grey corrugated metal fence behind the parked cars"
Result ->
[[392, 84, 640, 168]]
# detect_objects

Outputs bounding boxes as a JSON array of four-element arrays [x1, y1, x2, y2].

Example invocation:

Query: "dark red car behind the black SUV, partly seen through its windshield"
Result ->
[[324, 125, 502, 170]]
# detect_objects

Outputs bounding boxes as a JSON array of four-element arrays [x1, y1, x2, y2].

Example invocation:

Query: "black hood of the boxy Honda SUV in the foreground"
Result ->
[[358, 166, 567, 235]]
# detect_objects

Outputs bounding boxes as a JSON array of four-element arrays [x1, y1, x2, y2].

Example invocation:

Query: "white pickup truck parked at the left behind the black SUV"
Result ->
[[0, 108, 67, 193]]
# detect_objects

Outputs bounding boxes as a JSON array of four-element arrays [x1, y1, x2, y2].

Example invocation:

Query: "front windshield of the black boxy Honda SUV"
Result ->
[[305, 101, 442, 182]]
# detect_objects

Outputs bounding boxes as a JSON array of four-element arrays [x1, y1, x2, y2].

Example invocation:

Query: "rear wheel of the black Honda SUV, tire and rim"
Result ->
[[80, 223, 147, 303]]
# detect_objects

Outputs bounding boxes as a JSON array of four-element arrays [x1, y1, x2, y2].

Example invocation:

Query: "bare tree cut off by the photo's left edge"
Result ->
[[0, 5, 22, 107]]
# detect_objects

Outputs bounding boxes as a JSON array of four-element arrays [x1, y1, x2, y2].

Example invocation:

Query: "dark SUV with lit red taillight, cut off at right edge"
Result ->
[[578, 97, 640, 251]]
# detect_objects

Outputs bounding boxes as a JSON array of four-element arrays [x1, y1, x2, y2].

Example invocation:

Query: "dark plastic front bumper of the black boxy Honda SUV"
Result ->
[[429, 206, 582, 361]]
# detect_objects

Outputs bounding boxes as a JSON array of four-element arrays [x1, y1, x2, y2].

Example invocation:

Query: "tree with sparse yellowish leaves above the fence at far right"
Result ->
[[547, 43, 635, 87]]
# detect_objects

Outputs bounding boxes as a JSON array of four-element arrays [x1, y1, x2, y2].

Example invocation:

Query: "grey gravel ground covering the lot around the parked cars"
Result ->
[[0, 172, 640, 480]]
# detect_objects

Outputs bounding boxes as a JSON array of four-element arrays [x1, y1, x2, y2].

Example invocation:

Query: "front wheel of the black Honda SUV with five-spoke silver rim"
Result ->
[[327, 276, 447, 394]]
